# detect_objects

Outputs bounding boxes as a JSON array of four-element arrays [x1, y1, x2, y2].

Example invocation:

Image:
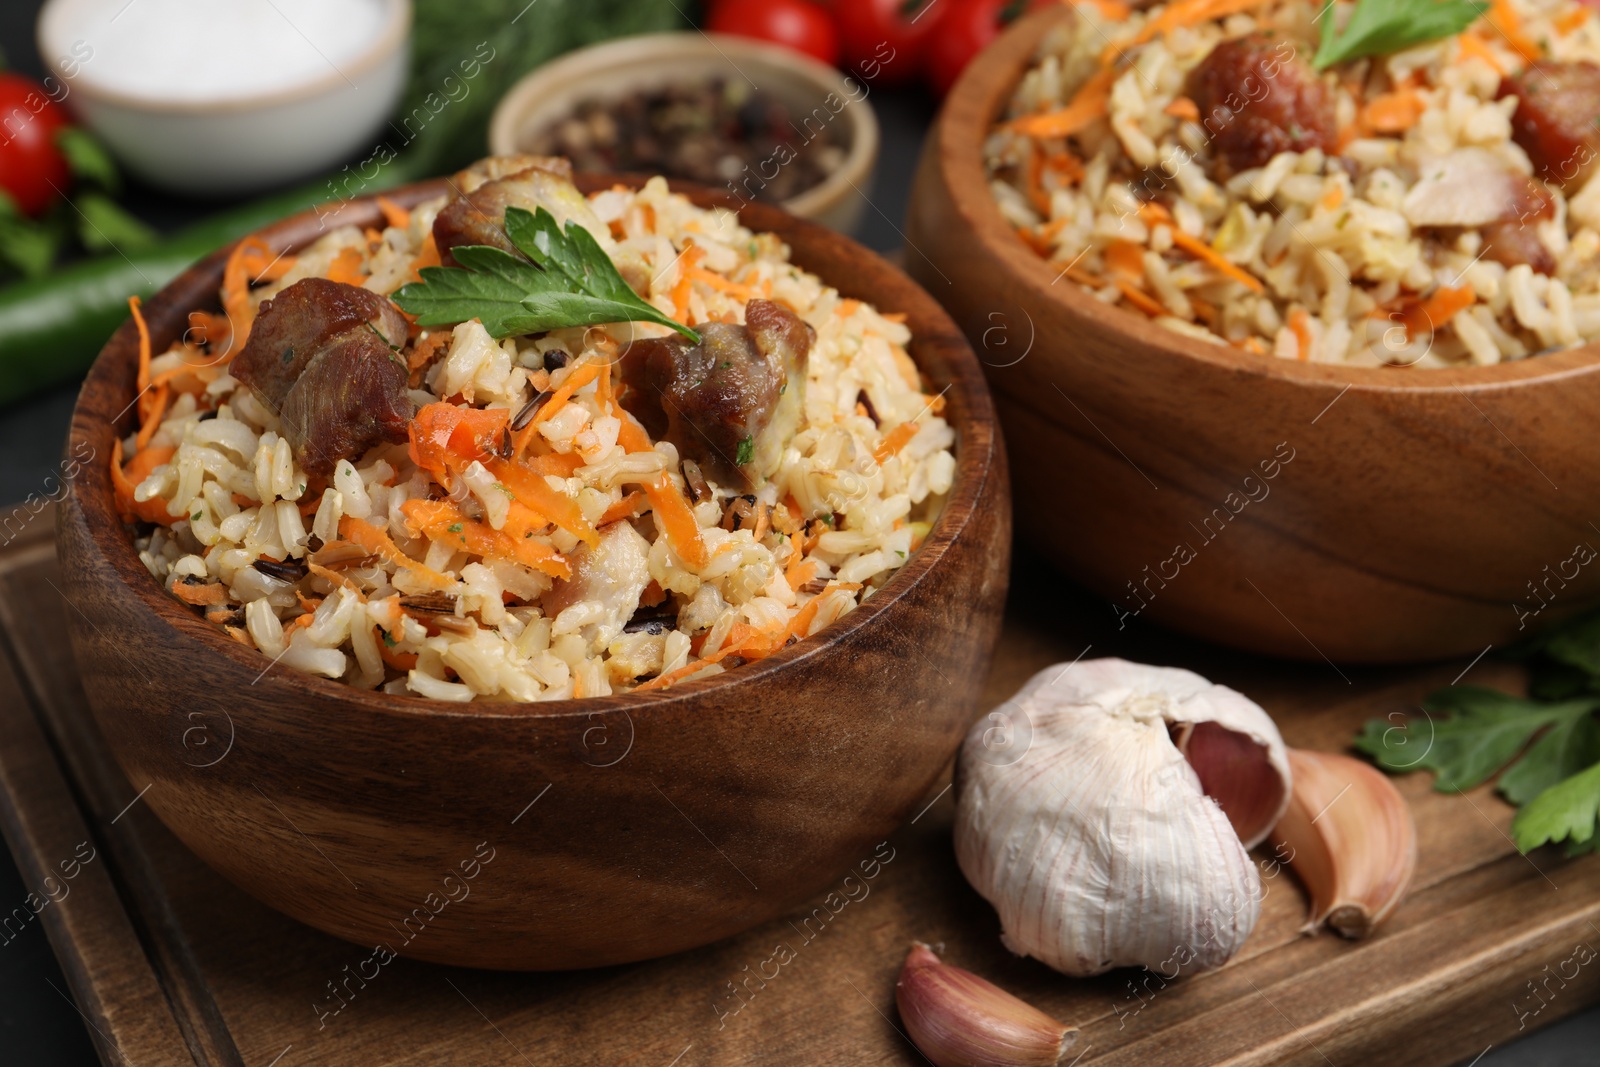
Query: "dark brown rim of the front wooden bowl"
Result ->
[[67, 174, 1010, 718]]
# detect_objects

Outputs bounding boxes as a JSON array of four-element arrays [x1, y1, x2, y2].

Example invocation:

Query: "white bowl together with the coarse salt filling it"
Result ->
[[38, 0, 411, 195]]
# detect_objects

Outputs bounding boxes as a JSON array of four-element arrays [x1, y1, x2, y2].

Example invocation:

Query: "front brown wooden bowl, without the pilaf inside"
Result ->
[[59, 179, 1011, 969]]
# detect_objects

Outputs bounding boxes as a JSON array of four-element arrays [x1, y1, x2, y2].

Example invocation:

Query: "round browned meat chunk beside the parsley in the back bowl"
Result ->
[[1189, 34, 1338, 179]]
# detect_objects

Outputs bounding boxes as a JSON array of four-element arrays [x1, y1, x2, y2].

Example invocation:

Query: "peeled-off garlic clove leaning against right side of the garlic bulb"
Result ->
[[1272, 749, 1416, 937]]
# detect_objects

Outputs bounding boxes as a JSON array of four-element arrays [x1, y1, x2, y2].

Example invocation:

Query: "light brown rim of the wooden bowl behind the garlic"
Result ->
[[931, 3, 1600, 394]]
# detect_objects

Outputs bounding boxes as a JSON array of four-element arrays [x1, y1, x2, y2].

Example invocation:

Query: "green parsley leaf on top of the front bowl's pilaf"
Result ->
[[394, 208, 699, 344]]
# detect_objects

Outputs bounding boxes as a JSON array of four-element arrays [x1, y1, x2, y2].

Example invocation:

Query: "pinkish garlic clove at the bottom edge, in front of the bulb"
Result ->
[[894, 941, 1078, 1067]]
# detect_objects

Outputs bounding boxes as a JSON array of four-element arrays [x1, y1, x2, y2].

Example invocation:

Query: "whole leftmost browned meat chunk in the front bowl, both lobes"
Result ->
[[230, 278, 411, 475]]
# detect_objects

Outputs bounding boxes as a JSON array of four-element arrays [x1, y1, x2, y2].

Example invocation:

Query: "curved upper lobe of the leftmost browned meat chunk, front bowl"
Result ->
[[230, 278, 406, 411]]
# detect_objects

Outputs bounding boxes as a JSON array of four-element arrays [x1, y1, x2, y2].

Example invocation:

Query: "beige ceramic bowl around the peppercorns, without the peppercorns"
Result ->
[[490, 32, 878, 234]]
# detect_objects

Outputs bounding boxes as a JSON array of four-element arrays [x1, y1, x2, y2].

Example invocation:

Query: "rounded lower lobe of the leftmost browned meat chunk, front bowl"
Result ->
[[280, 330, 411, 475]]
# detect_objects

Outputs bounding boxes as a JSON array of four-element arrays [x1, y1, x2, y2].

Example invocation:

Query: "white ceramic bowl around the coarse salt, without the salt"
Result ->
[[38, 0, 411, 197]]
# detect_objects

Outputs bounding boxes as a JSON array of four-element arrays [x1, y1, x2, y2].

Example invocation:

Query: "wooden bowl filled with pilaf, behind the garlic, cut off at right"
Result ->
[[906, 0, 1600, 662]]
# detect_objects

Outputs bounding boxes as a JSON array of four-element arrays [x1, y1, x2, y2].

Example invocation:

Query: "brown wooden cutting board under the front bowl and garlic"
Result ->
[[0, 514, 1600, 1067]]
